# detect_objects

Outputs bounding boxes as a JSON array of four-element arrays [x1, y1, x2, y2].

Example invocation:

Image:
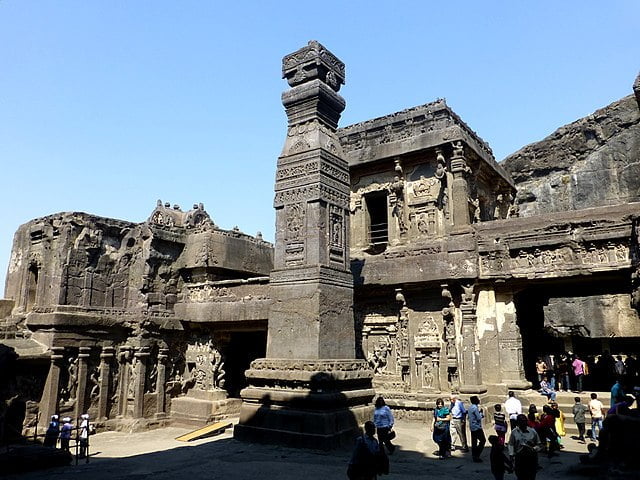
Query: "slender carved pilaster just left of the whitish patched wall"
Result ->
[[460, 286, 487, 393]]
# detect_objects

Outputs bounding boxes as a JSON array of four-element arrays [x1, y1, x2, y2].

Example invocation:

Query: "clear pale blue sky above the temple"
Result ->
[[0, 0, 640, 296]]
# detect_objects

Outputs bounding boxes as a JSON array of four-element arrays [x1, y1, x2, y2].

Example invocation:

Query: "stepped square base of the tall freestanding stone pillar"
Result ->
[[234, 359, 375, 450]]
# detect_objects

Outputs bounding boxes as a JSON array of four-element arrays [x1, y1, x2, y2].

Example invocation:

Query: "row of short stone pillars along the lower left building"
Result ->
[[40, 345, 168, 424]]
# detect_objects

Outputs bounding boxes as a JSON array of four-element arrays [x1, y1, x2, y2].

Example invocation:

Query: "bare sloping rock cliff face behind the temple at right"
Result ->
[[502, 95, 640, 216]]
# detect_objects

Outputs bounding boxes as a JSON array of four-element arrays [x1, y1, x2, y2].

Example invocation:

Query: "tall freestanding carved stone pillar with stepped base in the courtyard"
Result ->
[[234, 41, 374, 448]]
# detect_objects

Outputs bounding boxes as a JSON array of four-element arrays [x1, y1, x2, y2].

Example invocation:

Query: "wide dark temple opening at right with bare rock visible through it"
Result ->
[[514, 276, 640, 390]]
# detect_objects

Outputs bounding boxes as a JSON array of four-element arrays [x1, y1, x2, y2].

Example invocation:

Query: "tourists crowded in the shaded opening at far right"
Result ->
[[535, 350, 640, 398]]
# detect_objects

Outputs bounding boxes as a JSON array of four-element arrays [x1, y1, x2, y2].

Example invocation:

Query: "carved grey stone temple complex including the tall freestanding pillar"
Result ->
[[0, 42, 640, 447]]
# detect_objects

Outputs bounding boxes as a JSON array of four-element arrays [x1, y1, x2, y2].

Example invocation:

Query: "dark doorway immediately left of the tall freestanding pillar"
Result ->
[[225, 331, 267, 398]]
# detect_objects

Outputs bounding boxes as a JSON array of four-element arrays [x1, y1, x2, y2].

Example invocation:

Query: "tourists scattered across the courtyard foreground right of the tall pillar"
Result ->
[[348, 382, 635, 480]]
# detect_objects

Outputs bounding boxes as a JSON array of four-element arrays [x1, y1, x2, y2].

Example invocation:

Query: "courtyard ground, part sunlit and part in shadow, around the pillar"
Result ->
[[7, 421, 586, 480]]
